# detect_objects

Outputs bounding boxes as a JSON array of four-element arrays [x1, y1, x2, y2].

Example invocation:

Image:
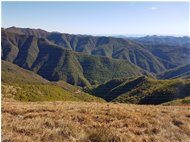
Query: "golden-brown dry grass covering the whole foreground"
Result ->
[[2, 100, 190, 142]]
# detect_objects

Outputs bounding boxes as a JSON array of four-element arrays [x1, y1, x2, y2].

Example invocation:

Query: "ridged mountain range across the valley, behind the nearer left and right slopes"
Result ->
[[1, 27, 190, 86]]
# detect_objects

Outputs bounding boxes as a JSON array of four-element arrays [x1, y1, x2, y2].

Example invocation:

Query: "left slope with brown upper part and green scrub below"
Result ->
[[1, 61, 104, 102]]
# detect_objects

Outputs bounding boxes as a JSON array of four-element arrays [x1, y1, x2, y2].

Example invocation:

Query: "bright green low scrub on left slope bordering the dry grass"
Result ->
[[2, 84, 104, 102]]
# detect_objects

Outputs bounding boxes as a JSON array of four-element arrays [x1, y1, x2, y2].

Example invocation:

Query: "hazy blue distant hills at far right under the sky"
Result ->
[[134, 35, 190, 69]]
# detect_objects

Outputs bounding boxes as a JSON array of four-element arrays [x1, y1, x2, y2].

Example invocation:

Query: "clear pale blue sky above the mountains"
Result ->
[[1, 1, 190, 35]]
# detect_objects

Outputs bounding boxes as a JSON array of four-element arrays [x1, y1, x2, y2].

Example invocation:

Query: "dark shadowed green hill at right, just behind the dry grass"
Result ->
[[90, 76, 190, 104]]
